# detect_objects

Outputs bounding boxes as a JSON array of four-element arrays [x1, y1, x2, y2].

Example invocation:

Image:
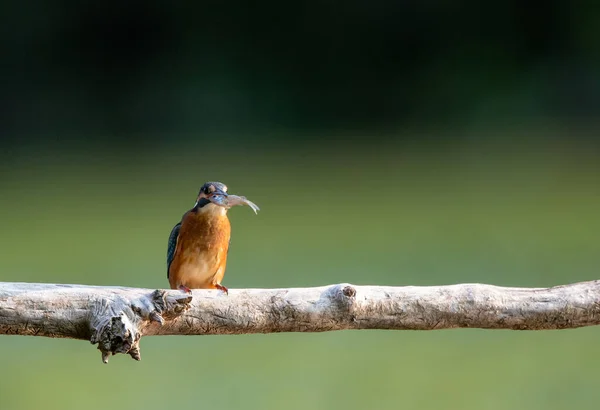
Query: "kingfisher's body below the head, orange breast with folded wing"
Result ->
[[169, 204, 231, 289]]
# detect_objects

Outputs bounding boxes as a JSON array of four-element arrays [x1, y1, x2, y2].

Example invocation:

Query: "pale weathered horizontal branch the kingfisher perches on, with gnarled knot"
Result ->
[[0, 281, 600, 363]]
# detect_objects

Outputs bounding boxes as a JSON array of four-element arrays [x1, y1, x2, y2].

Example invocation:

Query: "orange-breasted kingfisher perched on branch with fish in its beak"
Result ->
[[167, 182, 259, 294]]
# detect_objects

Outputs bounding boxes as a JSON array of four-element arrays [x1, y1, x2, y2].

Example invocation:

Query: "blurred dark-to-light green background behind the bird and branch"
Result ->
[[0, 1, 600, 410]]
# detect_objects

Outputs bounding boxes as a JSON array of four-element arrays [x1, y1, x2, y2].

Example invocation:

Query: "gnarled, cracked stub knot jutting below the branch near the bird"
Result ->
[[90, 290, 192, 363]]
